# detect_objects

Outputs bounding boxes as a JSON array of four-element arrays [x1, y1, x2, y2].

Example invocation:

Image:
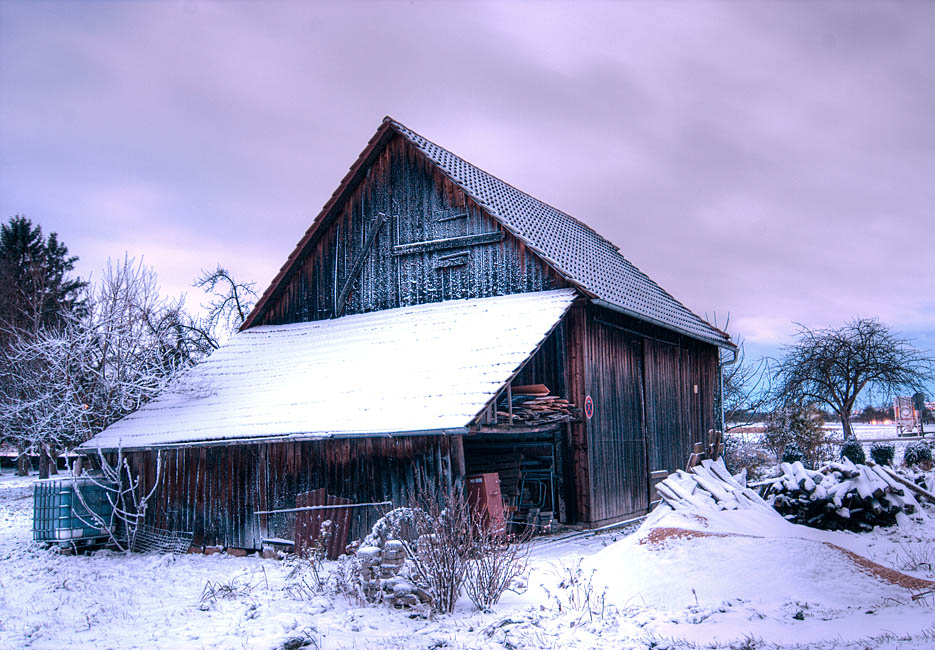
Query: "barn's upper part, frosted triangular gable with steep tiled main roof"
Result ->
[[243, 118, 731, 346]]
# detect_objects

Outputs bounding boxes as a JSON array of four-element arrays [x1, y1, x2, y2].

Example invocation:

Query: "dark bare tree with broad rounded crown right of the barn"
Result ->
[[773, 318, 935, 438]]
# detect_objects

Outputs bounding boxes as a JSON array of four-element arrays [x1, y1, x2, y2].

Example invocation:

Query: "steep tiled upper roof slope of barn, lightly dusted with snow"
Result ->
[[387, 118, 728, 344]]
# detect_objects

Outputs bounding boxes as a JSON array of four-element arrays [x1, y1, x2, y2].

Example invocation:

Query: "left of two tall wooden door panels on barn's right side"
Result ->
[[587, 321, 649, 522]]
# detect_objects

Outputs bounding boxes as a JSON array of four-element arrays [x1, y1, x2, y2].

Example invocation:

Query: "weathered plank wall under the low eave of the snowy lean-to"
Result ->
[[128, 436, 450, 549]]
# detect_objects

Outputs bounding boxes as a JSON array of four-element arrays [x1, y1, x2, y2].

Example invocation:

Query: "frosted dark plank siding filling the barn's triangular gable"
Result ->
[[259, 137, 565, 324]]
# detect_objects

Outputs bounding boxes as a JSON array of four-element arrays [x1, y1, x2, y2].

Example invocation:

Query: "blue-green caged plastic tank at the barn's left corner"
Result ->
[[32, 478, 113, 543]]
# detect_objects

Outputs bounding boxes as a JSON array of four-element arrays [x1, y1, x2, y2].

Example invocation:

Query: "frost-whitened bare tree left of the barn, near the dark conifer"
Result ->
[[0, 258, 206, 476]]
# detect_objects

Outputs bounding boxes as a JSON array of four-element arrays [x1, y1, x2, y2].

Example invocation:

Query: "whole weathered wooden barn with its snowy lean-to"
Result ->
[[77, 118, 734, 549]]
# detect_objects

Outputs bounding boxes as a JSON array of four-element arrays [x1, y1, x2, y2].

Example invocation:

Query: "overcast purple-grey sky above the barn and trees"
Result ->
[[0, 2, 935, 372]]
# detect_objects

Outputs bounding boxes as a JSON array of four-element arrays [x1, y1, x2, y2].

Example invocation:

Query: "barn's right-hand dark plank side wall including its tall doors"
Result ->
[[565, 305, 717, 525]]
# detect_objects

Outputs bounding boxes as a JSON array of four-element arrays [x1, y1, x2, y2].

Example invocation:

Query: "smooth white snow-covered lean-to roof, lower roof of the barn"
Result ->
[[81, 289, 577, 449]]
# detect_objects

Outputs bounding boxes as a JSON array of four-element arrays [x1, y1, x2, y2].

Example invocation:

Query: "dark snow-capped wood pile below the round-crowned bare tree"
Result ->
[[763, 458, 922, 532]]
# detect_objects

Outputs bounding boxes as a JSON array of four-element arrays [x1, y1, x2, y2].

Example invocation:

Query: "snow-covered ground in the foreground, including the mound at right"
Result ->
[[0, 473, 935, 650]]
